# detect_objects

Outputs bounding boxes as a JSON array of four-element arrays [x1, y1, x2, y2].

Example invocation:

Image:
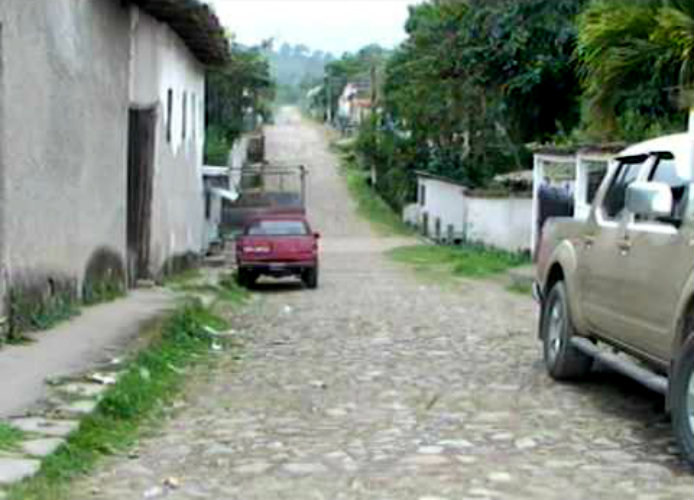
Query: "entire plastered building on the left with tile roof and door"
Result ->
[[0, 0, 230, 323]]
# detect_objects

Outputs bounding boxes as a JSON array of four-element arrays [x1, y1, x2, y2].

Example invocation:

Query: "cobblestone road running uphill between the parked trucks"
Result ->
[[72, 107, 694, 500]]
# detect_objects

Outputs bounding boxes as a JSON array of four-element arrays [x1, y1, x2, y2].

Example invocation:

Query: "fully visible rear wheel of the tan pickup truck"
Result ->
[[541, 281, 593, 380]]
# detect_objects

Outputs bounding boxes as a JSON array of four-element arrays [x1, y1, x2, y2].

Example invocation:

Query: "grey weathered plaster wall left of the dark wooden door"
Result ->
[[0, 0, 130, 294]]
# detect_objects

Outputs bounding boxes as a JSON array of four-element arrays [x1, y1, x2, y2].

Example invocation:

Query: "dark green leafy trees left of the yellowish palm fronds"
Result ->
[[327, 0, 582, 207]]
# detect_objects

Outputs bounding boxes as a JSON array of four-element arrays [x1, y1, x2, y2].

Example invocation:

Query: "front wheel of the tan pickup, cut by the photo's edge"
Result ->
[[670, 336, 694, 465]]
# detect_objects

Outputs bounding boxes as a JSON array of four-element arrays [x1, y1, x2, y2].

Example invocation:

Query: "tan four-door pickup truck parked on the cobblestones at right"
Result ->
[[534, 134, 694, 464]]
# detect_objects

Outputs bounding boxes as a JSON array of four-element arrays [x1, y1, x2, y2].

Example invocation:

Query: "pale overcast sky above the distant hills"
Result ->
[[208, 0, 419, 56]]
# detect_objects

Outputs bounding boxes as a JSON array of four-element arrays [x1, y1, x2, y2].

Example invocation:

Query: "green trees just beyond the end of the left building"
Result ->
[[205, 44, 275, 165]]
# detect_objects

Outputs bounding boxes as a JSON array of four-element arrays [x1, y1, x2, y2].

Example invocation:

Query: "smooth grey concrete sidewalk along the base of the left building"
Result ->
[[0, 288, 177, 418]]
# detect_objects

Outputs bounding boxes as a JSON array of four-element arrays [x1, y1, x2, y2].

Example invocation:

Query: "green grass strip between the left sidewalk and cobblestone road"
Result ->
[[8, 292, 241, 500]]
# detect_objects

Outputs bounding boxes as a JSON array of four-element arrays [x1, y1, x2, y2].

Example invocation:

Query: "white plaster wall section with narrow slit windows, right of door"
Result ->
[[130, 9, 206, 274]]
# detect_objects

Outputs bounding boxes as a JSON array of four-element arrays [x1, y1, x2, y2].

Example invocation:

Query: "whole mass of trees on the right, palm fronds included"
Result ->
[[325, 0, 694, 208]]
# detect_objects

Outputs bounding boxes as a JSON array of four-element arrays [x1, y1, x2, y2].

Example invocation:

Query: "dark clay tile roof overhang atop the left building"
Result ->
[[131, 0, 231, 66]]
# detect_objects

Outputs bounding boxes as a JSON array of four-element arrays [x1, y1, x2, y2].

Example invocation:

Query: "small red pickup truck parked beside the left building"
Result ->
[[236, 215, 320, 288]]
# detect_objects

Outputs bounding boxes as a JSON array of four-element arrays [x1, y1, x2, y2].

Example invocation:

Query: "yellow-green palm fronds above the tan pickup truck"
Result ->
[[577, 0, 694, 139]]
